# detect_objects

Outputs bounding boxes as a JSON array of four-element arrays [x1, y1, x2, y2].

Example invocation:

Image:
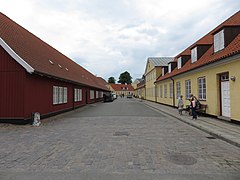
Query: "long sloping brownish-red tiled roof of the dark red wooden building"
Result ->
[[0, 13, 108, 90]]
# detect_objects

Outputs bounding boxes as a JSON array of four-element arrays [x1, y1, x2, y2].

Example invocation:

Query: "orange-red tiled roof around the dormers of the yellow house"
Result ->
[[156, 11, 240, 82]]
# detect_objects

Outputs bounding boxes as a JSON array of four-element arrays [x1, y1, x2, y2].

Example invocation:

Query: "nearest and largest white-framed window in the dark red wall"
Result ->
[[53, 86, 67, 104]]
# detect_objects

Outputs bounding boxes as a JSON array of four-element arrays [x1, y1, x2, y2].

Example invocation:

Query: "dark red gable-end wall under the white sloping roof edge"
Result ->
[[0, 47, 25, 119]]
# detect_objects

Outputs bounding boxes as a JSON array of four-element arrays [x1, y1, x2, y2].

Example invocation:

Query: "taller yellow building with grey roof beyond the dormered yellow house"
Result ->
[[144, 57, 173, 101]]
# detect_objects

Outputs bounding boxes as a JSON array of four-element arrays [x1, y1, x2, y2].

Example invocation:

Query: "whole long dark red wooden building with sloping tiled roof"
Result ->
[[0, 13, 109, 122]]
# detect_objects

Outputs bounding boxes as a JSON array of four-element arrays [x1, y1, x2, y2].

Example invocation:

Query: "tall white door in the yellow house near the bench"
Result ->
[[221, 81, 231, 117]]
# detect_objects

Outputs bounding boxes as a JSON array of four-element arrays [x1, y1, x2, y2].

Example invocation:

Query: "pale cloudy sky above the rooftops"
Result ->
[[0, 0, 240, 81]]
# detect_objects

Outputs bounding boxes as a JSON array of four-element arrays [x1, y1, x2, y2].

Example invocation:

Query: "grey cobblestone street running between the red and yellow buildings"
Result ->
[[0, 99, 240, 179]]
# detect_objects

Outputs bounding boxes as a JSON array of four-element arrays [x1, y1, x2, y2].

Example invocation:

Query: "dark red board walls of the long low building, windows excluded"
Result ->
[[0, 47, 102, 119]]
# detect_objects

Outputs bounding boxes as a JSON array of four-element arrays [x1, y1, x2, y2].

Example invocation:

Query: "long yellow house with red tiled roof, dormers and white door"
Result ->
[[156, 12, 240, 121]]
